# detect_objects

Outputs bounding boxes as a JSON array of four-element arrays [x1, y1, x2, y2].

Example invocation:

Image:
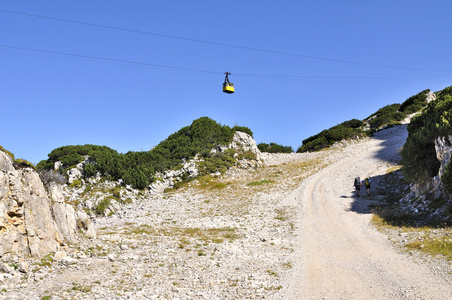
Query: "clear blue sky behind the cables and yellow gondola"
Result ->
[[0, 0, 452, 163]]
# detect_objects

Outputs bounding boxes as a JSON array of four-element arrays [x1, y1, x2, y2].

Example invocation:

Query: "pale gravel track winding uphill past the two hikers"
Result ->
[[288, 126, 452, 300]]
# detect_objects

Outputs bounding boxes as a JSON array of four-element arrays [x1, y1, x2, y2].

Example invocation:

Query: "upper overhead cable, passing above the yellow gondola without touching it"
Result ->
[[0, 9, 452, 72]]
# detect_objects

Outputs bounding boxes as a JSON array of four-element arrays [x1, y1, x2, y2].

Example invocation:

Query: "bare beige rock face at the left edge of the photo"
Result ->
[[0, 151, 95, 257]]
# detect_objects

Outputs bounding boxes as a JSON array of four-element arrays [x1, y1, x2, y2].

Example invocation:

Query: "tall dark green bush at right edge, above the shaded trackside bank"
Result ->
[[401, 87, 452, 184]]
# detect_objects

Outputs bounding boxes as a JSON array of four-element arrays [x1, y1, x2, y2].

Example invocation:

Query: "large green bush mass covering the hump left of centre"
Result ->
[[38, 117, 252, 189]]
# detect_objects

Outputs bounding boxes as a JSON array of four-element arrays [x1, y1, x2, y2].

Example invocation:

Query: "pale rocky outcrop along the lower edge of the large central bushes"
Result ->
[[42, 131, 263, 220]]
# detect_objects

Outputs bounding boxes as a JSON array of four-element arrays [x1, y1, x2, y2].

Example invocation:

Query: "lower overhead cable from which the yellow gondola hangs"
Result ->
[[0, 44, 448, 79]]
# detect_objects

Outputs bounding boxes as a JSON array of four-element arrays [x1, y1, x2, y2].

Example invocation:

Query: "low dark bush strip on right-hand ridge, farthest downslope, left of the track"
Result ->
[[297, 119, 364, 153]]
